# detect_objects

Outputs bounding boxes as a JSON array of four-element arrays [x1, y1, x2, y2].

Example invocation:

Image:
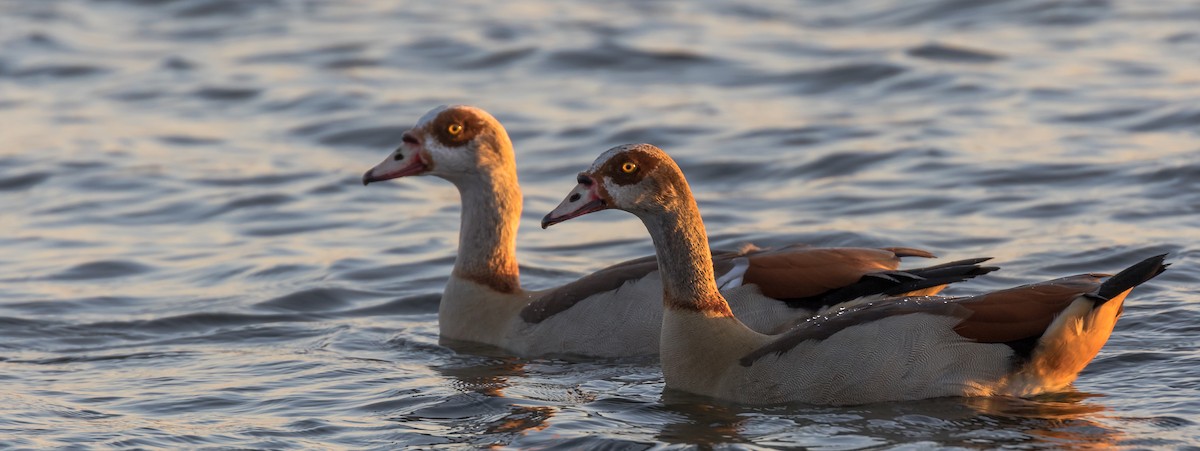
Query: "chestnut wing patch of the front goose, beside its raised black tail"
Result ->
[[954, 273, 1109, 343]]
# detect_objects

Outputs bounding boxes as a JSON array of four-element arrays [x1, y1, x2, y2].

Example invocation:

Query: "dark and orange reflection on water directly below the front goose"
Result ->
[[648, 391, 1126, 449]]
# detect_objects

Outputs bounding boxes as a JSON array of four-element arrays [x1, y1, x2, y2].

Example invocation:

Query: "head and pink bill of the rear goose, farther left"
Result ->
[[362, 106, 516, 185]]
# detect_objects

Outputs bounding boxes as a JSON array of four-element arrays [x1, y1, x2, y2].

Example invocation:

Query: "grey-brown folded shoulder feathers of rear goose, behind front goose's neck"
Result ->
[[521, 251, 739, 324]]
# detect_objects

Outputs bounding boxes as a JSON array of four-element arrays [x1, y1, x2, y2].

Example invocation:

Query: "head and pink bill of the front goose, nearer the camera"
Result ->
[[541, 144, 691, 228]]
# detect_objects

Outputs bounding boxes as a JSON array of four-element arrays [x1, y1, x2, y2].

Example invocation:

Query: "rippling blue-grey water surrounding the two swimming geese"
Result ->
[[0, 0, 1200, 450]]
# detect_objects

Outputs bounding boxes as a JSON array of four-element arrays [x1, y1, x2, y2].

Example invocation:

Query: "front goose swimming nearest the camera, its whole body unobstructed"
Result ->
[[542, 144, 1166, 404]]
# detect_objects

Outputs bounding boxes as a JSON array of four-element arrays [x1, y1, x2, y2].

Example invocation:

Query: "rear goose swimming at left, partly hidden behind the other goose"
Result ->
[[362, 106, 991, 357]]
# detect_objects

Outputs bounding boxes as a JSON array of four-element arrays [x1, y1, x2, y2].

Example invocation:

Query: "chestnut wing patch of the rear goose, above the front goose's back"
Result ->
[[744, 246, 934, 299]]
